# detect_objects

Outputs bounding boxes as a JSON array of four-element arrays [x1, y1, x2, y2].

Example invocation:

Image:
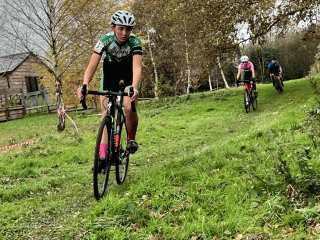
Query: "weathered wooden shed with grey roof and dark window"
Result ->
[[0, 52, 48, 121]]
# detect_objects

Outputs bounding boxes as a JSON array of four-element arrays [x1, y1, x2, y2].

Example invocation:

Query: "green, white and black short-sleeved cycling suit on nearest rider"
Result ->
[[94, 32, 142, 91]]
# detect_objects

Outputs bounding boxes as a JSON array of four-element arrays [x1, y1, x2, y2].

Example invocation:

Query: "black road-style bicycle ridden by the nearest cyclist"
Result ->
[[81, 81, 136, 200]]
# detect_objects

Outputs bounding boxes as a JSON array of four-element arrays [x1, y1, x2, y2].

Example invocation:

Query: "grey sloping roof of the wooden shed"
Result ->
[[0, 52, 31, 73]]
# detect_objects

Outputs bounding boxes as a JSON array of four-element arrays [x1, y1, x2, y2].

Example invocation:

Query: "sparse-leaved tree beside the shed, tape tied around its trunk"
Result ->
[[0, 0, 111, 131]]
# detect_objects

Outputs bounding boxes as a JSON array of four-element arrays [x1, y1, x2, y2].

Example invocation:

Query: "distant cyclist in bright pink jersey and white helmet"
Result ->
[[237, 56, 257, 104]]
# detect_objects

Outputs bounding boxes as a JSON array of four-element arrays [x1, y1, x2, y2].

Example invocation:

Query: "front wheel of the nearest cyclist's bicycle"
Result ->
[[93, 117, 112, 200]]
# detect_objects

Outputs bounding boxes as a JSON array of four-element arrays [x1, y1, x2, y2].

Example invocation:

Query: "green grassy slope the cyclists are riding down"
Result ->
[[0, 79, 320, 239]]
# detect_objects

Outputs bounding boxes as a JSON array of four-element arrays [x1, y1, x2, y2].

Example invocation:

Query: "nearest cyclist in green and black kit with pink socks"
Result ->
[[77, 11, 142, 155]]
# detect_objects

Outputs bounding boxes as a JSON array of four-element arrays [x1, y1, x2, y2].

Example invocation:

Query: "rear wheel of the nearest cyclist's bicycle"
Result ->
[[116, 113, 129, 184]]
